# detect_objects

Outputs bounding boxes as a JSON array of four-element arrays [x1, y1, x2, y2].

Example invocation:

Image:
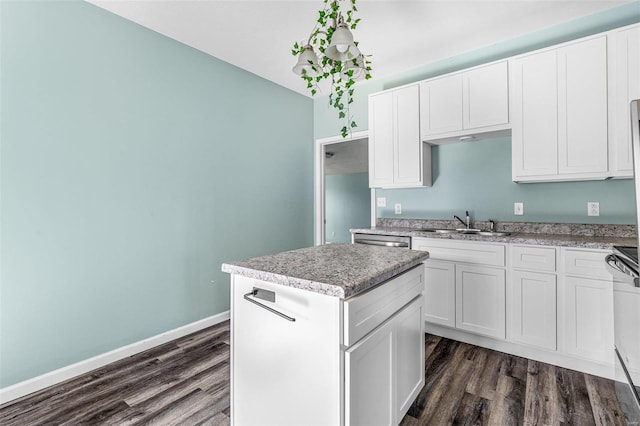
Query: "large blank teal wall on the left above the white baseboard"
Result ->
[[0, 0, 313, 387]]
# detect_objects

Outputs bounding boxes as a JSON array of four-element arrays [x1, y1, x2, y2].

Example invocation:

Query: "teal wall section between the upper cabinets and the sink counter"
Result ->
[[376, 137, 635, 224]]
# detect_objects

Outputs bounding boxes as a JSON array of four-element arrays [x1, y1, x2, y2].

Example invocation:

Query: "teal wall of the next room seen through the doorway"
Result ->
[[324, 173, 371, 243]]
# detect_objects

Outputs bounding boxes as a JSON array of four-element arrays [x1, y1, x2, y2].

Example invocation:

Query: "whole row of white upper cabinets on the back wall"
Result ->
[[369, 24, 640, 188]]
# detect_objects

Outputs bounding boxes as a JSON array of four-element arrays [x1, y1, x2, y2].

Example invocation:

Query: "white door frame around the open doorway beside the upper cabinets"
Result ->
[[314, 130, 376, 245]]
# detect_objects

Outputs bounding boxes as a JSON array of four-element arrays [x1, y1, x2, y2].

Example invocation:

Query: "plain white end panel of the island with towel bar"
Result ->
[[231, 275, 342, 426]]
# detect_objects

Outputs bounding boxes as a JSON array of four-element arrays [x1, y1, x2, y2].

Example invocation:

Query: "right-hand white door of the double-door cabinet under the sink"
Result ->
[[456, 265, 506, 339]]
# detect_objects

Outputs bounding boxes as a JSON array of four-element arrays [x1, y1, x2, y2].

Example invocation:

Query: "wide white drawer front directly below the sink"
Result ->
[[411, 238, 505, 266]]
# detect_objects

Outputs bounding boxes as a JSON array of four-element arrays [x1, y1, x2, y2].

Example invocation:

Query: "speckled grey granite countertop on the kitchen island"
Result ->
[[222, 244, 429, 299]]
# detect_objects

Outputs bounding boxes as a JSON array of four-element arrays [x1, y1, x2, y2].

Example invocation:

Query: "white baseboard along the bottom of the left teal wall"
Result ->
[[0, 311, 230, 404]]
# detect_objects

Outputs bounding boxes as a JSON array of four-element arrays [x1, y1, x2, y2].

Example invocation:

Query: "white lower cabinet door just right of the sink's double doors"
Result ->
[[511, 271, 557, 350]]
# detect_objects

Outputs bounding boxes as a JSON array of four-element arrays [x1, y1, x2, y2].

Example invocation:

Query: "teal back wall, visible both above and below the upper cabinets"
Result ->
[[314, 1, 640, 224]]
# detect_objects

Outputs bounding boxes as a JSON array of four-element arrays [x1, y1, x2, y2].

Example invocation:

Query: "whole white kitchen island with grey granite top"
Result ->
[[222, 244, 428, 425]]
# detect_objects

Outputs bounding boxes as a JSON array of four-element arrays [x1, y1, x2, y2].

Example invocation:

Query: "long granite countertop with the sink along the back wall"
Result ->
[[351, 226, 637, 250]]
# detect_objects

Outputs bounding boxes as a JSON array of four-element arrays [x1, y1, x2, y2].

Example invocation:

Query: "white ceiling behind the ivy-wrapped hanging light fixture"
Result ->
[[88, 0, 631, 95]]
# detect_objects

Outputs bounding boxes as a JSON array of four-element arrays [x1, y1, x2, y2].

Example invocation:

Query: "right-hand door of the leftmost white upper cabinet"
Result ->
[[393, 85, 428, 186]]
